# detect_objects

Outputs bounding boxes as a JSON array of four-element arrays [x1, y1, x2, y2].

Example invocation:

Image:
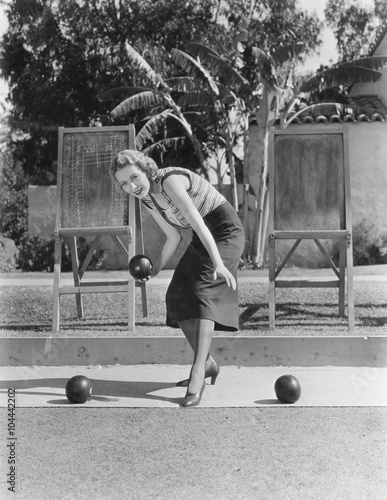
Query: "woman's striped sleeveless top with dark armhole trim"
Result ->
[[142, 167, 226, 229]]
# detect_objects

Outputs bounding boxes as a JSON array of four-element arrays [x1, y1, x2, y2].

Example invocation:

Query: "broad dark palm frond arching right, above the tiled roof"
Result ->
[[300, 66, 382, 92]]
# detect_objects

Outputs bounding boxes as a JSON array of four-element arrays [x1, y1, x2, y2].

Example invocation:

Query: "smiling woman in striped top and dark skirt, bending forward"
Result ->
[[111, 150, 245, 407]]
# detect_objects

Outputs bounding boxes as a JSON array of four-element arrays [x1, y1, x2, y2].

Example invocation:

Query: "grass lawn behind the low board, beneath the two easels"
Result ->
[[0, 266, 387, 337]]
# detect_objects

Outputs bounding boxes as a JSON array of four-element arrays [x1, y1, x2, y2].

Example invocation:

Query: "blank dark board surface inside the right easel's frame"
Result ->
[[273, 133, 345, 231]]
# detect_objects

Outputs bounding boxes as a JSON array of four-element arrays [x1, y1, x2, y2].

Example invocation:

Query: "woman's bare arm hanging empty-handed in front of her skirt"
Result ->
[[163, 175, 236, 290]]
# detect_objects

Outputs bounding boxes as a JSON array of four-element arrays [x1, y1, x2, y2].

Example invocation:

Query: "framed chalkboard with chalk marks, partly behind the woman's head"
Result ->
[[57, 126, 134, 228]]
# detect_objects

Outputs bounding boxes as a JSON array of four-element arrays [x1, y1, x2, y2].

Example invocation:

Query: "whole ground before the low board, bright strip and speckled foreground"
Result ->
[[0, 272, 387, 500]]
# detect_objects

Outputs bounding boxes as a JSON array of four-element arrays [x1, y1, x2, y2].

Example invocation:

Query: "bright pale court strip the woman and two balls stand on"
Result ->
[[0, 365, 387, 409]]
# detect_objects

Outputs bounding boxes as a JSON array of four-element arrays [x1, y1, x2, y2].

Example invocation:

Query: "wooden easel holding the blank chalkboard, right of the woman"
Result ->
[[269, 125, 354, 331]]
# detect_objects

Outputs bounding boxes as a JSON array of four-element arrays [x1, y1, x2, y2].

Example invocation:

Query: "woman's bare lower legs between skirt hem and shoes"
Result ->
[[179, 318, 215, 394]]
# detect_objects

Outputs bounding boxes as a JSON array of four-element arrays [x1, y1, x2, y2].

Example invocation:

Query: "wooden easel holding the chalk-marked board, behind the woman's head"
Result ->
[[52, 125, 148, 332]]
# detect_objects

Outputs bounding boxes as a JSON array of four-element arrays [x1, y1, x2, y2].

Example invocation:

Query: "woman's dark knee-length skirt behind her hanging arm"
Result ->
[[166, 202, 245, 331]]
